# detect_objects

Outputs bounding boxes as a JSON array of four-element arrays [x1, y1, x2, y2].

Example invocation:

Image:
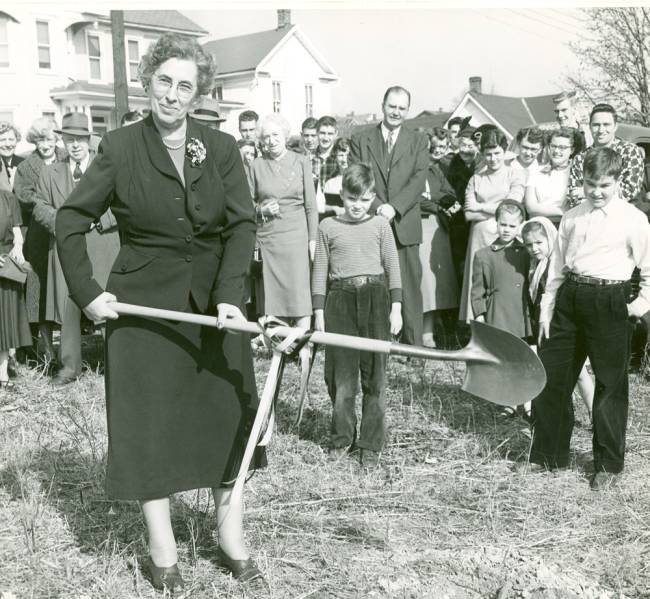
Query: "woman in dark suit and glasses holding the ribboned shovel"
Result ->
[[56, 34, 264, 591]]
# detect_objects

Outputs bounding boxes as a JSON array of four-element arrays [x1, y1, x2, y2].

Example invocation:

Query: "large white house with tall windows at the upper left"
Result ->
[[0, 7, 207, 151]]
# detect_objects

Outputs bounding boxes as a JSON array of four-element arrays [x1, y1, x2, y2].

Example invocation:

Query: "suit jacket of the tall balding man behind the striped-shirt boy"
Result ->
[[350, 125, 429, 246]]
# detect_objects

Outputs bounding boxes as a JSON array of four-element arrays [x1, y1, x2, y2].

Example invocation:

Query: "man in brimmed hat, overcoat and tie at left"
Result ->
[[33, 112, 120, 386]]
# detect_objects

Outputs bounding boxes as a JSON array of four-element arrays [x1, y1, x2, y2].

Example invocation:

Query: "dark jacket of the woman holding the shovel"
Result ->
[[56, 116, 256, 311]]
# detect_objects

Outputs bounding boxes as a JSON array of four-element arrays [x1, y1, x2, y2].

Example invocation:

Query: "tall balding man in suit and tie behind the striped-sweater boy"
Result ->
[[350, 86, 429, 345]]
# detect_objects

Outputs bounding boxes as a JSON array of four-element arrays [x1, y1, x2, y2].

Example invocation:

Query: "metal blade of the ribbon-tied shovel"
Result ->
[[461, 322, 546, 406]]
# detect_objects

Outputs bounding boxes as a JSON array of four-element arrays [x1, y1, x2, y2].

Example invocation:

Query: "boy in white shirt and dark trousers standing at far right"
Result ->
[[530, 147, 650, 491]]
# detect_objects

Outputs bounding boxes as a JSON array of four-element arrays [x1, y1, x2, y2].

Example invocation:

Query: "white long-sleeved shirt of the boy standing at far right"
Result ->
[[540, 197, 650, 322]]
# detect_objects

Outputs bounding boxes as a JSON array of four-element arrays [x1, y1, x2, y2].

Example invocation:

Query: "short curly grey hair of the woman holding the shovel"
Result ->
[[138, 33, 217, 97]]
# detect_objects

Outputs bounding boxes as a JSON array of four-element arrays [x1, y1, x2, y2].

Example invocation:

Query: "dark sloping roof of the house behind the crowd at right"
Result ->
[[467, 92, 557, 136]]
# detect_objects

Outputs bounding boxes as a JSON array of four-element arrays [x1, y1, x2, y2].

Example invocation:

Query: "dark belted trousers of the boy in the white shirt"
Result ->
[[530, 280, 631, 473]]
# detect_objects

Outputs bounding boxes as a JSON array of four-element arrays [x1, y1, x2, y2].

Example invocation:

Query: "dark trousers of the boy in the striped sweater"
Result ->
[[325, 275, 390, 451]]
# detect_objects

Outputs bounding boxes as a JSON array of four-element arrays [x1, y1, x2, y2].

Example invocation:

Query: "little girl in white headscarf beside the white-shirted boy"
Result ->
[[521, 216, 594, 419]]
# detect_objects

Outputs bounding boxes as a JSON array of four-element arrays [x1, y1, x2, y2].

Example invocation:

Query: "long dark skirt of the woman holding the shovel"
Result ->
[[106, 308, 266, 500]]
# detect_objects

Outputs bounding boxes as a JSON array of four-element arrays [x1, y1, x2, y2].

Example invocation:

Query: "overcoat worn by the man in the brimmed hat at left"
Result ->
[[32, 153, 120, 324]]
